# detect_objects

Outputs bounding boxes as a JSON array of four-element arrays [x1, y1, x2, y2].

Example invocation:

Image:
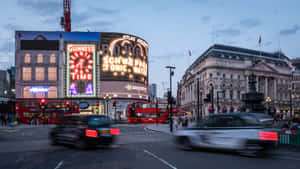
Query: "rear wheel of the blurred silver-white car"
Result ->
[[239, 142, 262, 157]]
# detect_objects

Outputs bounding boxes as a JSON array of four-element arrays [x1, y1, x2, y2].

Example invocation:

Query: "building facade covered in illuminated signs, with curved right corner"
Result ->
[[15, 31, 149, 113]]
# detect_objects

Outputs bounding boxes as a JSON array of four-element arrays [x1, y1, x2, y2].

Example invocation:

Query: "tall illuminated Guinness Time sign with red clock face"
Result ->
[[67, 44, 96, 97]]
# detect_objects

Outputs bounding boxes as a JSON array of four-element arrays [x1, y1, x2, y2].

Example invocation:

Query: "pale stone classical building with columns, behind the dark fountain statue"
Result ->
[[177, 44, 293, 115]]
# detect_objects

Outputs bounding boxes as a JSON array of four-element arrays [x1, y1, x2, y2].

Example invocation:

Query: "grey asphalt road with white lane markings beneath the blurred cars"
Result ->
[[0, 125, 300, 169]]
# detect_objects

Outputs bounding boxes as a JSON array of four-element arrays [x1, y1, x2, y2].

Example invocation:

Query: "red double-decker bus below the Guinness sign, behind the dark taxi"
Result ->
[[16, 99, 79, 124]]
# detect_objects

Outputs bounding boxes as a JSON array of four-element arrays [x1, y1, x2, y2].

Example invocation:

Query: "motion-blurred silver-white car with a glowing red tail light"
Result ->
[[174, 113, 278, 156]]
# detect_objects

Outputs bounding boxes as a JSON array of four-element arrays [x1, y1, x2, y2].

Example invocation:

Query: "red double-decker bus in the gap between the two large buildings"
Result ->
[[126, 102, 185, 124]]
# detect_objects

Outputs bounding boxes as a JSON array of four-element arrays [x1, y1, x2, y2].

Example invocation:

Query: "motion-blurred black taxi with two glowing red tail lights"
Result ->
[[50, 115, 120, 149]]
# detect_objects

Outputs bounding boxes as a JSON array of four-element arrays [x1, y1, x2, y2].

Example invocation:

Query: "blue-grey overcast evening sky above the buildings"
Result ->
[[0, 0, 300, 95]]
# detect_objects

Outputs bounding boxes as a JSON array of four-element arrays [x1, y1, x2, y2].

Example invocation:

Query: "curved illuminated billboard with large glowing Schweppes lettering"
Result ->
[[99, 33, 148, 85]]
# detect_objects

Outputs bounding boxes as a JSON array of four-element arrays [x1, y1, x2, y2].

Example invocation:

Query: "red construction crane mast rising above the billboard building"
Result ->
[[60, 0, 71, 32]]
